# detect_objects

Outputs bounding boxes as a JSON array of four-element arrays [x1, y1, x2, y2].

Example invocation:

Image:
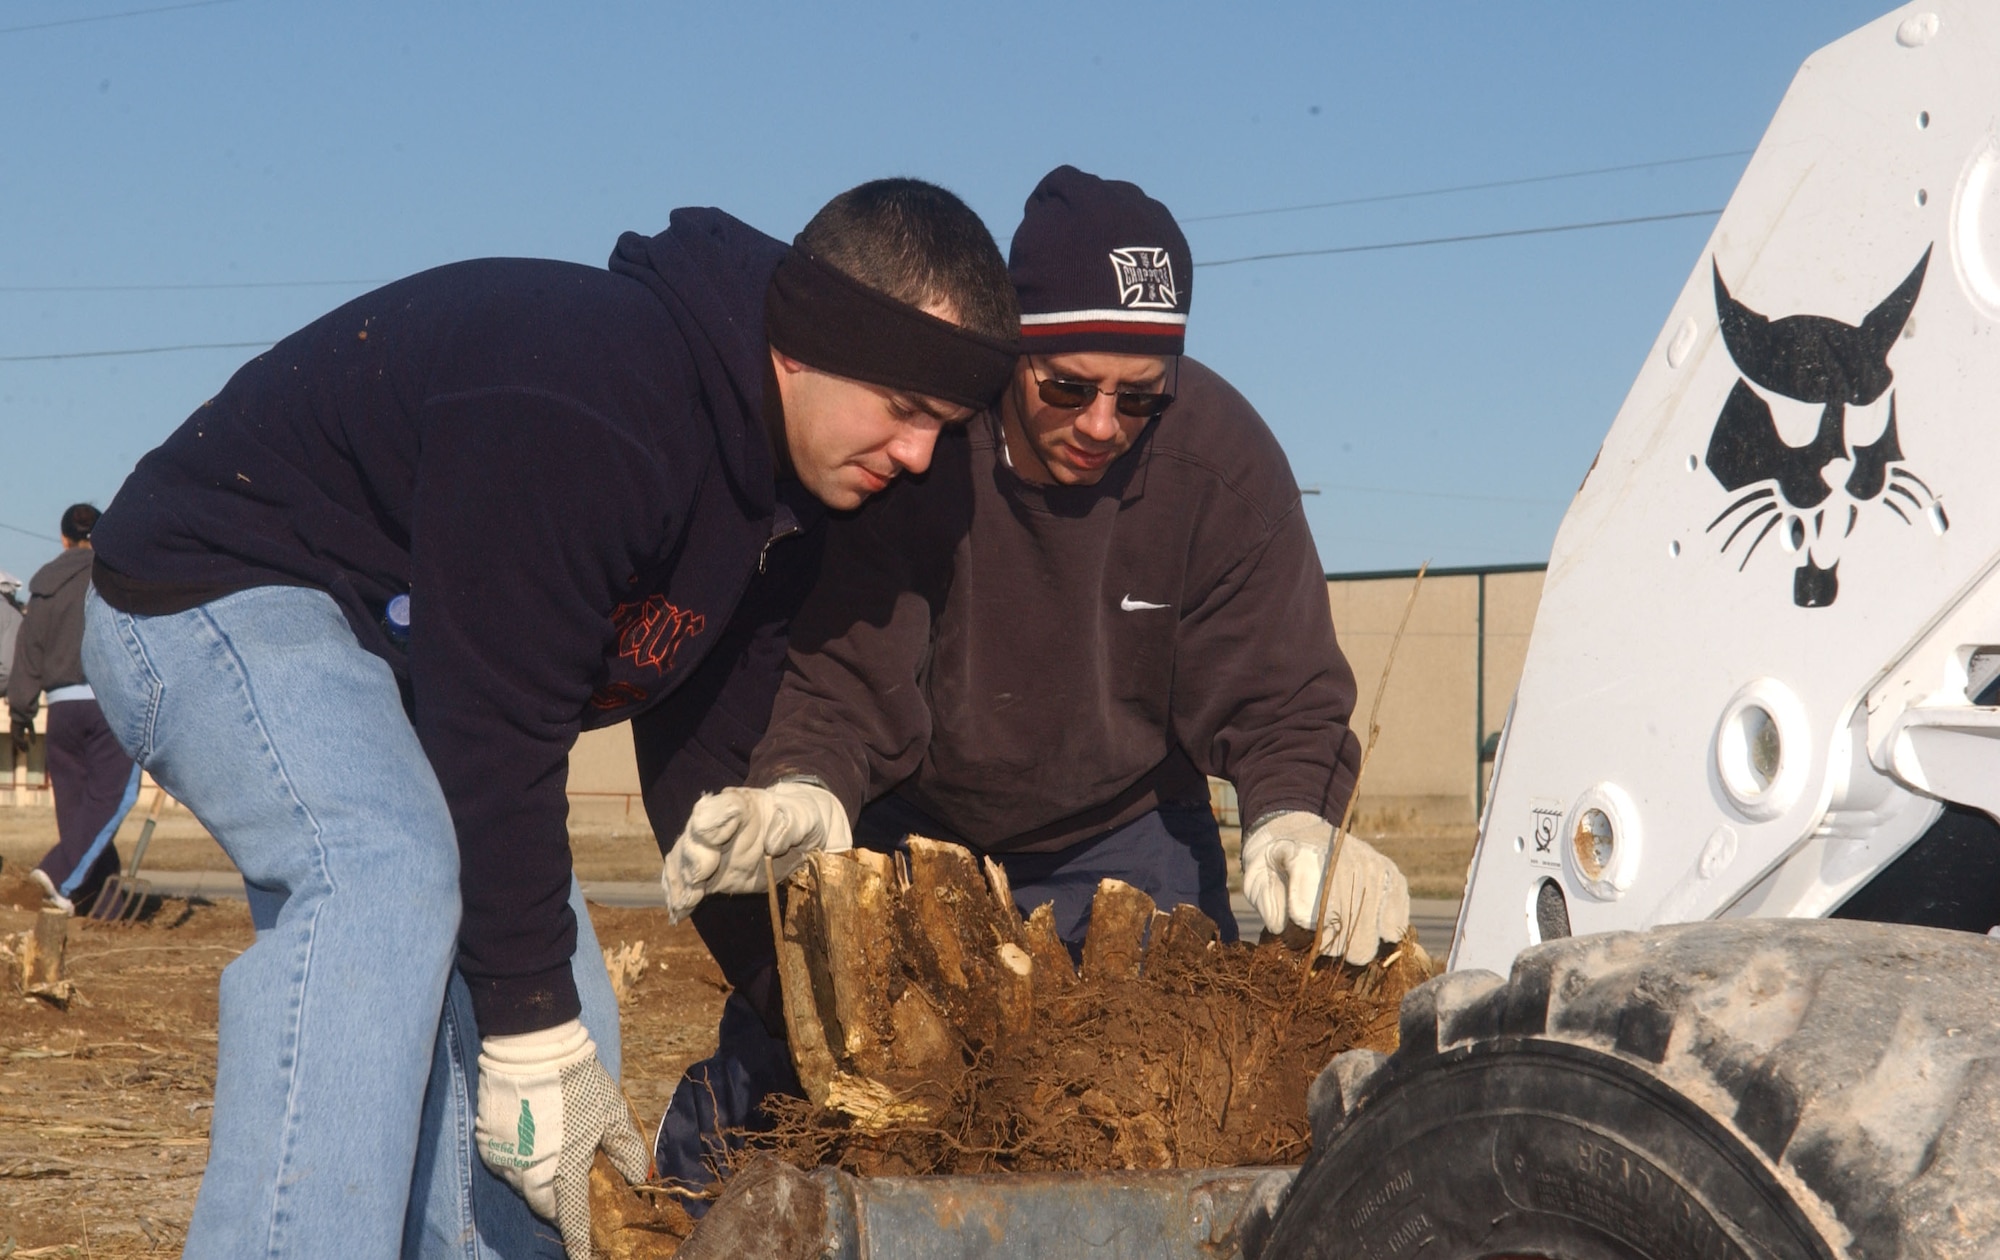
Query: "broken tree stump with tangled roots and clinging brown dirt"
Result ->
[[752, 838, 1432, 1176]]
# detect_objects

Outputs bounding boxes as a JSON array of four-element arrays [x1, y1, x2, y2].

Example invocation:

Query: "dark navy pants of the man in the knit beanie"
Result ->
[[652, 794, 1236, 1216]]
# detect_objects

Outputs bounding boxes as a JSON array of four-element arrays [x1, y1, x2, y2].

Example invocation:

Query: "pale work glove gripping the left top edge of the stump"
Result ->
[[660, 780, 854, 922]]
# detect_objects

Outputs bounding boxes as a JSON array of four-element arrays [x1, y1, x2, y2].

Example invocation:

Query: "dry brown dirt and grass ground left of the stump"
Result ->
[[0, 810, 724, 1260]]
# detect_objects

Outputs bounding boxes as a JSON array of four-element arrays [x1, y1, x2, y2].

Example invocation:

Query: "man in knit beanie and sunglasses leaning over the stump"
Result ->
[[656, 166, 1410, 1182]]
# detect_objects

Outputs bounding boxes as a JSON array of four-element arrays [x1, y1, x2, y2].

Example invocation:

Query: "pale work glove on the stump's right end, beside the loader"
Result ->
[[1244, 810, 1410, 966]]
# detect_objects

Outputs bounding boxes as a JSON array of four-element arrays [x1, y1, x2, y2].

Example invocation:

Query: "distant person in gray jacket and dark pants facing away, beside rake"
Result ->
[[0, 504, 138, 914]]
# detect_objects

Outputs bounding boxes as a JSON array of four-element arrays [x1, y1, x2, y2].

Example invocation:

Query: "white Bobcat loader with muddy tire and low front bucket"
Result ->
[[684, 0, 2000, 1260]]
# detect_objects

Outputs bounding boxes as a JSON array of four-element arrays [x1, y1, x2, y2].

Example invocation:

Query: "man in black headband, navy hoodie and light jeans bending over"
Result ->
[[84, 180, 1018, 1260]]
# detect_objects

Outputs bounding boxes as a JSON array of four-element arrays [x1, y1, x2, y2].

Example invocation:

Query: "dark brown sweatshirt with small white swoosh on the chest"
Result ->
[[750, 360, 1360, 852]]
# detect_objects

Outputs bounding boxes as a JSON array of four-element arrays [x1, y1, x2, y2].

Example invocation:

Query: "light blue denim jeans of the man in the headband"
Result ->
[[84, 586, 618, 1258]]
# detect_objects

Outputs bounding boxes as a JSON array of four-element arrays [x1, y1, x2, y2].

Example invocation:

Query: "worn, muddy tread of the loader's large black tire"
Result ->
[[1302, 920, 2000, 1260]]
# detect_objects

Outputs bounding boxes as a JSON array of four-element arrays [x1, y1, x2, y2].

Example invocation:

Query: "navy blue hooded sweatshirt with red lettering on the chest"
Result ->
[[94, 210, 820, 1036]]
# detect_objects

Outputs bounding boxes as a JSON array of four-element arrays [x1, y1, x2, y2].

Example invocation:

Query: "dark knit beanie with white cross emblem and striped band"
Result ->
[[1008, 166, 1194, 354]]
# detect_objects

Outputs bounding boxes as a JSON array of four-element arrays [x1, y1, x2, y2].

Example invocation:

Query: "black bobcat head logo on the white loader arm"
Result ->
[[1708, 250, 1950, 608]]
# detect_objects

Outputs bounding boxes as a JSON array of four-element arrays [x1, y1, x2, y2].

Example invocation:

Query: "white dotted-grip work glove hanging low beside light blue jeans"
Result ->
[[472, 1020, 652, 1260]]
